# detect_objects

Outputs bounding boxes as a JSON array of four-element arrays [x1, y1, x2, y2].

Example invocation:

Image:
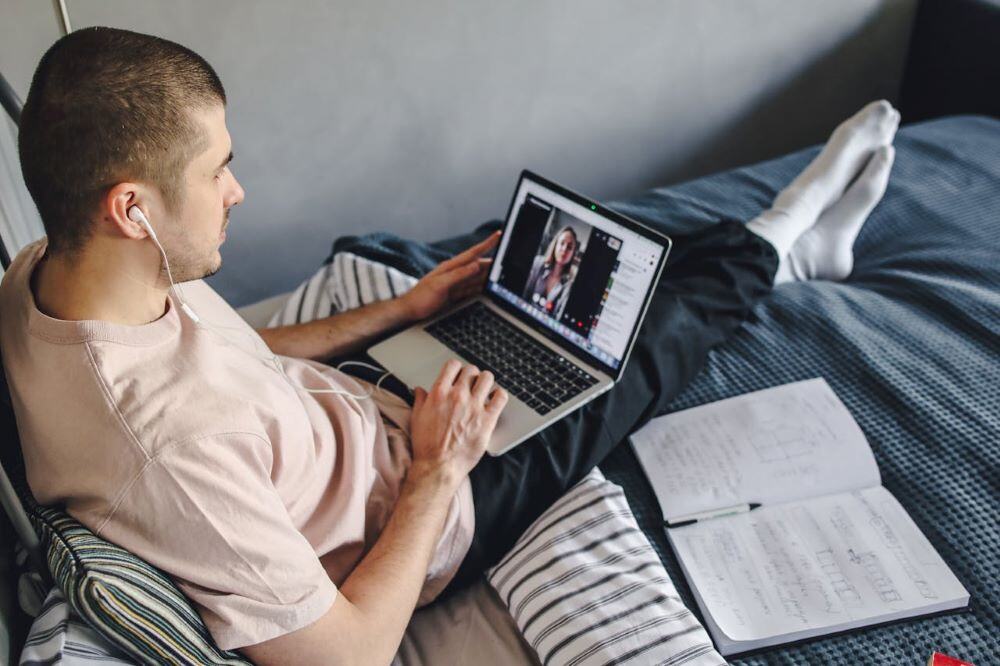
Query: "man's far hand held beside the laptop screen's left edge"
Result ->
[[400, 231, 500, 319]]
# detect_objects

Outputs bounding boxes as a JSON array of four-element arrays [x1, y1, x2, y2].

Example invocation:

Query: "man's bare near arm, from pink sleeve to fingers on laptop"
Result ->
[[243, 360, 507, 665]]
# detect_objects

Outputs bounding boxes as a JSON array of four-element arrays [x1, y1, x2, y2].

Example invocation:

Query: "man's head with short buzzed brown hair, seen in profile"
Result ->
[[18, 28, 243, 282]]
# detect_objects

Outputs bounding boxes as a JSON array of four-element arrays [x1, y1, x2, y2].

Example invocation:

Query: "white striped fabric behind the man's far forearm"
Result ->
[[268, 252, 417, 326]]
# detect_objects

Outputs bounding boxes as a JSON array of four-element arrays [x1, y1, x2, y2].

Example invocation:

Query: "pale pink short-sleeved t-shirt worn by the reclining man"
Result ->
[[0, 239, 474, 649]]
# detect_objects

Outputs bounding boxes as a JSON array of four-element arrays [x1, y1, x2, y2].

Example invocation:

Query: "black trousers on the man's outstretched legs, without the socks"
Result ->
[[452, 222, 778, 588]]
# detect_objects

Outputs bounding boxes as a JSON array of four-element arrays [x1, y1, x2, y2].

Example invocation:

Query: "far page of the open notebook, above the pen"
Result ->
[[632, 379, 882, 521]]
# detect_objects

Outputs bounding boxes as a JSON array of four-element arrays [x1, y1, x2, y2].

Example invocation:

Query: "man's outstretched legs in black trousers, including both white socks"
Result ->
[[449, 97, 899, 591]]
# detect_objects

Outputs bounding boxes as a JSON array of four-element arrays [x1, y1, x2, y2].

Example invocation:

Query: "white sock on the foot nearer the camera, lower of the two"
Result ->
[[774, 146, 896, 284]]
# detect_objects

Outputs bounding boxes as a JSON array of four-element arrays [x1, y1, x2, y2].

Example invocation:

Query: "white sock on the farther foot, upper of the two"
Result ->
[[747, 100, 899, 264]]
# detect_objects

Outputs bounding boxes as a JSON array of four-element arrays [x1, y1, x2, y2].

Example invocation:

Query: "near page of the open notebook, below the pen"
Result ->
[[667, 486, 969, 654]]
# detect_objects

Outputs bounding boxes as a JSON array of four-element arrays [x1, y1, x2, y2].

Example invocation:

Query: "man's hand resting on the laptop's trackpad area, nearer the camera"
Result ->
[[410, 359, 508, 486]]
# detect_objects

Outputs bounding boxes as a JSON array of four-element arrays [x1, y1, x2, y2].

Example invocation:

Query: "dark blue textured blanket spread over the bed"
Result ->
[[335, 116, 1000, 664]]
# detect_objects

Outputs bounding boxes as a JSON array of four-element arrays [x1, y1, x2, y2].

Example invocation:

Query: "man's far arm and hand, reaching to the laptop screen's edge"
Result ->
[[257, 232, 500, 361]]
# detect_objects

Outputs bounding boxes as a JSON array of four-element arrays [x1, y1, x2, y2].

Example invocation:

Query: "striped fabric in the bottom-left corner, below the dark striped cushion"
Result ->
[[19, 587, 135, 666]]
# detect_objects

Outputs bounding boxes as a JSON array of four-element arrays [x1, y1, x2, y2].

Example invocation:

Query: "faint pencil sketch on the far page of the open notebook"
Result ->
[[745, 396, 836, 463]]
